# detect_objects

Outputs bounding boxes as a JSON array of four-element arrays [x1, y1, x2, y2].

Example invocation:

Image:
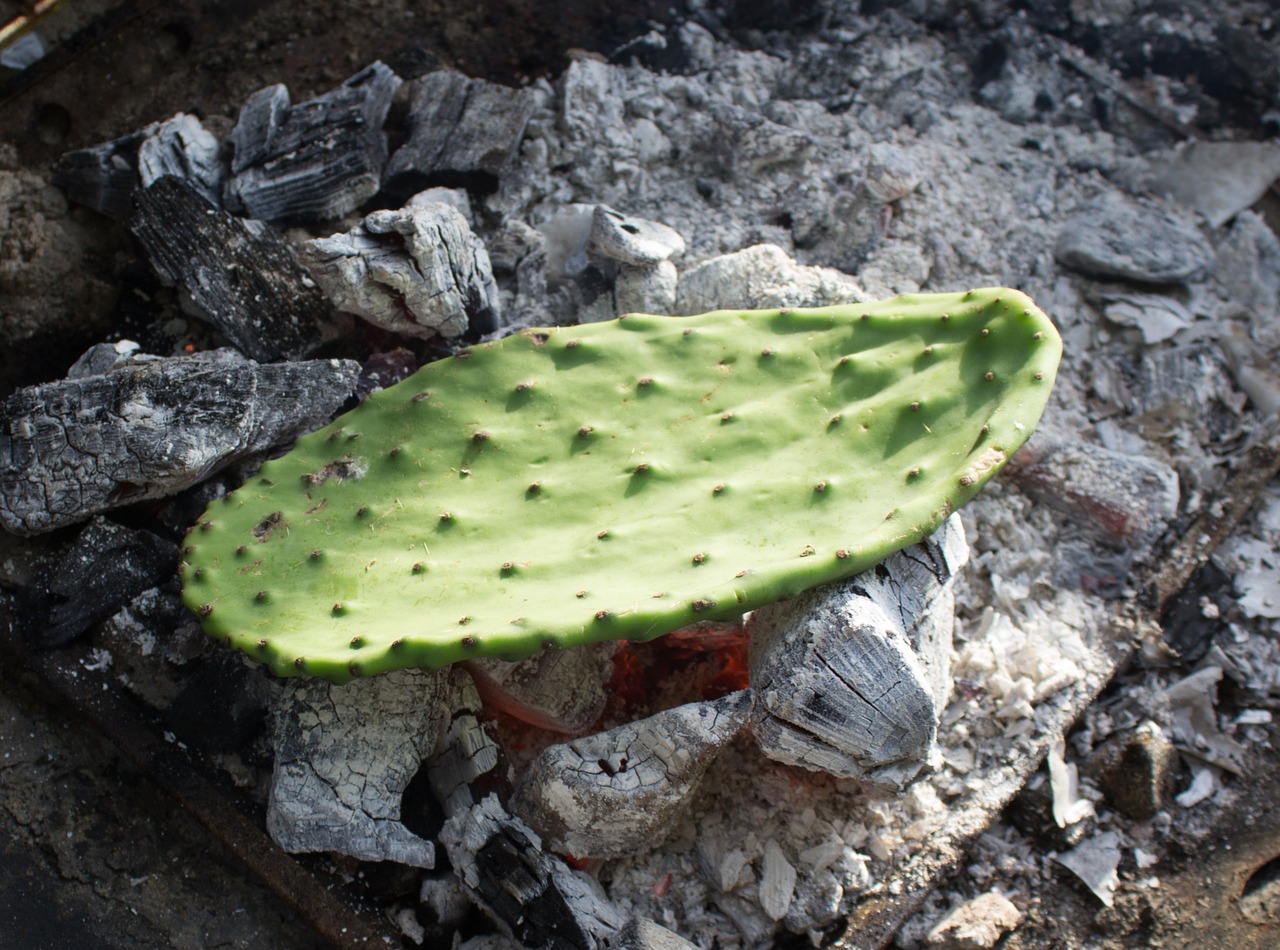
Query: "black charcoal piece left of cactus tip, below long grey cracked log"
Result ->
[[17, 517, 178, 649]]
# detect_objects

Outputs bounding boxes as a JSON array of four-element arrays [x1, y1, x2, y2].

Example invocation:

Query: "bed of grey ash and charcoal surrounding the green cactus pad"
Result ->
[[0, 3, 1280, 947]]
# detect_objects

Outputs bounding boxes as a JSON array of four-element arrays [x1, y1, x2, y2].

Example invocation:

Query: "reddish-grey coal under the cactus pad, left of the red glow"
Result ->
[[465, 641, 617, 734]]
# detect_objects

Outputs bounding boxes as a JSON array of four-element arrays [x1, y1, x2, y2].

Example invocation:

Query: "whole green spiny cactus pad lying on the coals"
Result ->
[[183, 289, 1061, 682]]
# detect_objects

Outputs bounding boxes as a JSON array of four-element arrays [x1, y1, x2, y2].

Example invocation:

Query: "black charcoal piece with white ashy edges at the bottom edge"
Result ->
[[440, 795, 627, 950]]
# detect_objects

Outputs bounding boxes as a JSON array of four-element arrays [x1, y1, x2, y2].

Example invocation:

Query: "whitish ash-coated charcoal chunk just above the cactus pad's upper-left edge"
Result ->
[[302, 202, 500, 339]]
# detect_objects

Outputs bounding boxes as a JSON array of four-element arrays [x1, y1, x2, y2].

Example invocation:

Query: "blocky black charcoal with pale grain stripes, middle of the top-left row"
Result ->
[[227, 63, 401, 221]]
